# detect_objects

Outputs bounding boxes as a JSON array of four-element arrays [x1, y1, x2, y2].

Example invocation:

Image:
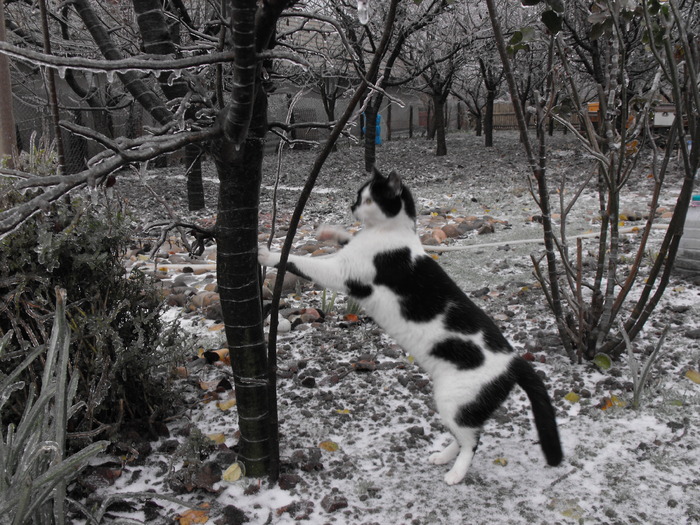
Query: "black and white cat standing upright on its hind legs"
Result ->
[[258, 170, 562, 485]]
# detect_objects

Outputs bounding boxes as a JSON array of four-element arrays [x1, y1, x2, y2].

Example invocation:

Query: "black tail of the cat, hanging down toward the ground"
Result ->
[[511, 357, 563, 466]]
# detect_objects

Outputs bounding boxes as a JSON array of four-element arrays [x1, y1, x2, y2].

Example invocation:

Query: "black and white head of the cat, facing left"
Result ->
[[351, 168, 416, 226]]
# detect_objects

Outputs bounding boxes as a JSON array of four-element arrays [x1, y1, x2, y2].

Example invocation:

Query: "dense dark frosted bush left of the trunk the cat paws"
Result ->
[[0, 194, 187, 438]]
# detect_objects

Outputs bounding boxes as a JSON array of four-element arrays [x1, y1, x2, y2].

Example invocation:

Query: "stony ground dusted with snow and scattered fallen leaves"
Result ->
[[83, 133, 700, 525]]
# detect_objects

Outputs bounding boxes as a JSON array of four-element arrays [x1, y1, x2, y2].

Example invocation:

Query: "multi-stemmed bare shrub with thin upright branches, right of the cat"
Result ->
[[488, 0, 700, 360]]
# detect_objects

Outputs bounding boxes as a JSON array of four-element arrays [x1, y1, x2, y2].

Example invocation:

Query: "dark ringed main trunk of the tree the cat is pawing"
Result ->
[[212, 81, 270, 477]]
